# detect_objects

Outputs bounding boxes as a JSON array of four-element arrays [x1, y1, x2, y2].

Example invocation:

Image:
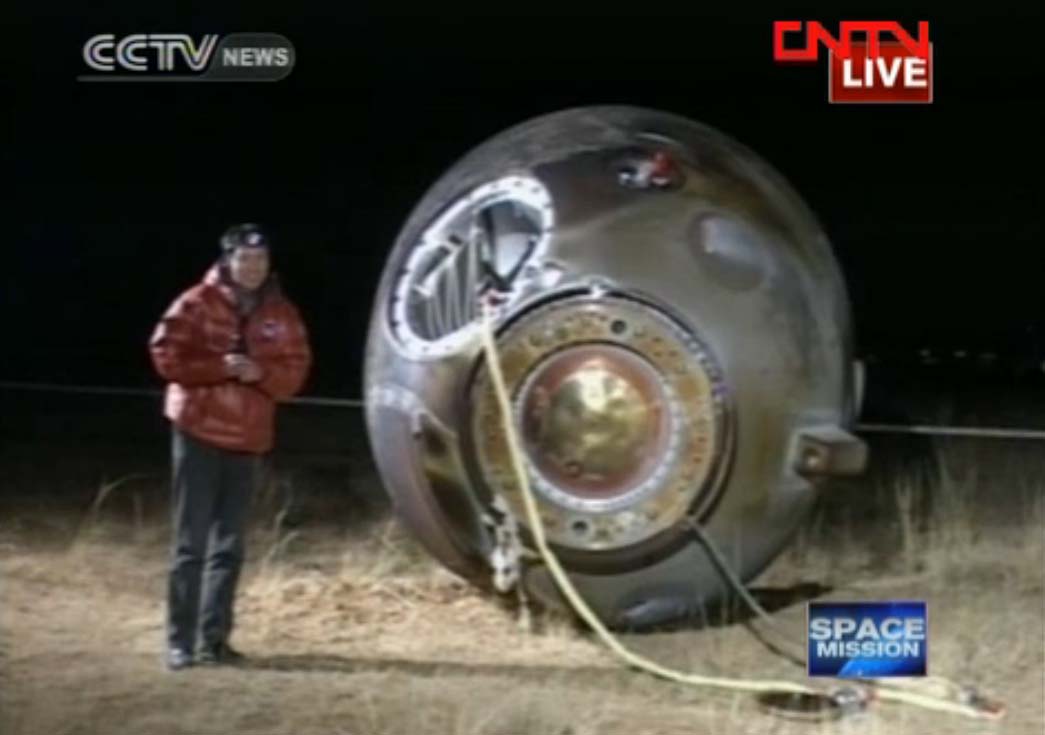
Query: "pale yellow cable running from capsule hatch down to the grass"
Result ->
[[480, 304, 1001, 719]]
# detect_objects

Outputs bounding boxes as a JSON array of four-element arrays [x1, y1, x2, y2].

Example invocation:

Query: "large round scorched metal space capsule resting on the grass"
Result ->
[[365, 107, 866, 628]]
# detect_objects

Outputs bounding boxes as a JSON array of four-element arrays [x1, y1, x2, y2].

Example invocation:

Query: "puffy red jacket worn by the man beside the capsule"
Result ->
[[149, 266, 311, 454]]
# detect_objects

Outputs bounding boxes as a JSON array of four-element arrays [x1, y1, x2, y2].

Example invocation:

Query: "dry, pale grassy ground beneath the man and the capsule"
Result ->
[[0, 430, 1045, 735]]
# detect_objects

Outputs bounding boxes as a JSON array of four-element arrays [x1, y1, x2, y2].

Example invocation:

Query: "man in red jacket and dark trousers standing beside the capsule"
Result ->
[[149, 225, 311, 670]]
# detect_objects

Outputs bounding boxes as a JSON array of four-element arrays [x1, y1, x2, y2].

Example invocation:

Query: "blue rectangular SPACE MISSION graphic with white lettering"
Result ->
[[807, 602, 929, 679]]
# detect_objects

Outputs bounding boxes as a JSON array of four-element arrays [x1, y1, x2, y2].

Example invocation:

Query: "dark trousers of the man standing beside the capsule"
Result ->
[[167, 429, 260, 652]]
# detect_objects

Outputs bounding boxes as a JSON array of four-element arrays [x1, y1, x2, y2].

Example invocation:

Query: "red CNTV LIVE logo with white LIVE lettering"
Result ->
[[773, 21, 932, 104]]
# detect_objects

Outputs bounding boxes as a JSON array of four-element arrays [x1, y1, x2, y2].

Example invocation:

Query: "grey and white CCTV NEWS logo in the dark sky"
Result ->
[[78, 33, 295, 82]]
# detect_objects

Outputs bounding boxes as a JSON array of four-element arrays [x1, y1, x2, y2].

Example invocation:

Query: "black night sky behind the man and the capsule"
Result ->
[[0, 2, 1045, 396]]
